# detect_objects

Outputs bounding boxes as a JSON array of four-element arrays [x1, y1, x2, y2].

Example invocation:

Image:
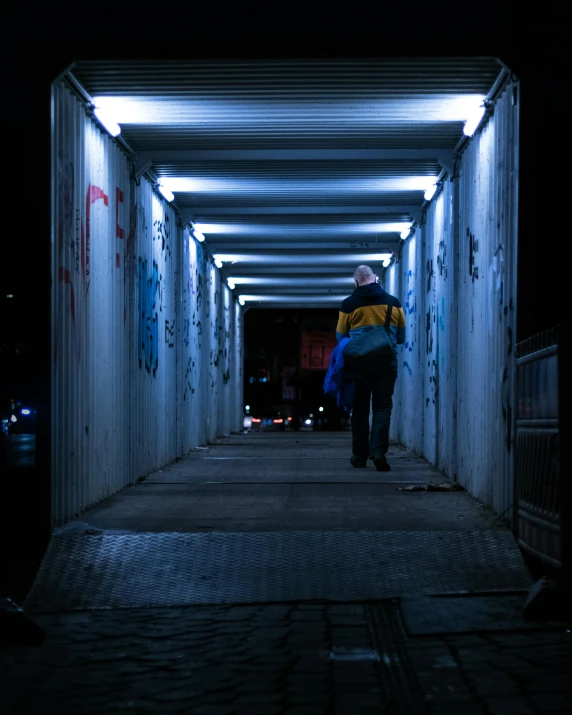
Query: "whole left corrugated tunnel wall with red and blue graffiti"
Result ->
[[52, 83, 242, 525]]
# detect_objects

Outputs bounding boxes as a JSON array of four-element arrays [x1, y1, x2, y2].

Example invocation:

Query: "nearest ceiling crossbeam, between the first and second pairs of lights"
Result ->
[[135, 148, 452, 170]]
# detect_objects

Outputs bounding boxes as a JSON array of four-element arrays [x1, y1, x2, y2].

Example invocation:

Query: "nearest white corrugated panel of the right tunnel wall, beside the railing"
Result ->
[[458, 85, 519, 513]]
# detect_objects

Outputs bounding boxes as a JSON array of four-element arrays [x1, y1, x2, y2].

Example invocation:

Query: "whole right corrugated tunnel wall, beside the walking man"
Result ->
[[386, 84, 519, 513]]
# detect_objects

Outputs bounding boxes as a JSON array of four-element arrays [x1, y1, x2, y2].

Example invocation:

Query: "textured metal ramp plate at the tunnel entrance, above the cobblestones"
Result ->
[[25, 531, 531, 613]]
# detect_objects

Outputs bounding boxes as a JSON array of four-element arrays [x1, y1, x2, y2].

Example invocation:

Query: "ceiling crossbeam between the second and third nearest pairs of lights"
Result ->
[[181, 204, 421, 226]]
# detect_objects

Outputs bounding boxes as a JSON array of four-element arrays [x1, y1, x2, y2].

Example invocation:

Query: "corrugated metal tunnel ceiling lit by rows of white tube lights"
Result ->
[[71, 57, 508, 307]]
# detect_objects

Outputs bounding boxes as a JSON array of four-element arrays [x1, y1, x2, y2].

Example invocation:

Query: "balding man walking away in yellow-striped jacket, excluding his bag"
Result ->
[[336, 266, 405, 472]]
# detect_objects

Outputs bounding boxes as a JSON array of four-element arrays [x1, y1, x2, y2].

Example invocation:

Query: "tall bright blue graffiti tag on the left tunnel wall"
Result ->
[[138, 256, 159, 377]]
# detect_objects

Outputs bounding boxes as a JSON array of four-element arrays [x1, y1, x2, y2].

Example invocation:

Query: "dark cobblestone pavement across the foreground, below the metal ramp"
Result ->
[[0, 601, 572, 715]]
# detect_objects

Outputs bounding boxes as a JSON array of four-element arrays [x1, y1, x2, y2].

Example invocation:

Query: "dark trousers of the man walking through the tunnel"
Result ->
[[352, 368, 397, 459]]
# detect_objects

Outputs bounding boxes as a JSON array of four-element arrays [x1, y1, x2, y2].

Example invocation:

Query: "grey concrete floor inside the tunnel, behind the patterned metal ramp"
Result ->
[[53, 432, 504, 533]]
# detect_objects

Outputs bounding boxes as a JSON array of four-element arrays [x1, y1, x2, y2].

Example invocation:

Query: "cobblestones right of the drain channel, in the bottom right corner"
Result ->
[[407, 629, 572, 715]]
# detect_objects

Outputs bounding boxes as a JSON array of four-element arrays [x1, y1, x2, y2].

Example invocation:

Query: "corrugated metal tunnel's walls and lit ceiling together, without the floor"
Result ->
[[51, 57, 520, 527]]
